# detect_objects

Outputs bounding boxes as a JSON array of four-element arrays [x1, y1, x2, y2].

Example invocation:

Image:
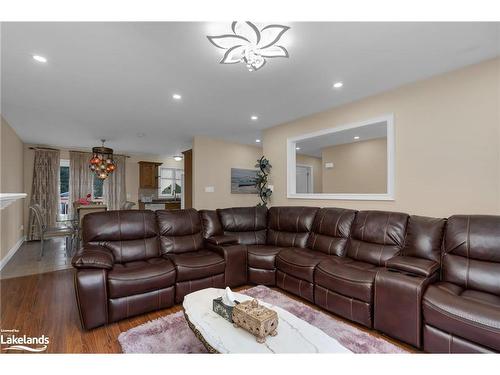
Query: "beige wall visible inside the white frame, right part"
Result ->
[[322, 138, 387, 194]]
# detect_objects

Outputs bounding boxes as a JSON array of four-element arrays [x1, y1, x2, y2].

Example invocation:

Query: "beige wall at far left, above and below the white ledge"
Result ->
[[0, 116, 25, 260]]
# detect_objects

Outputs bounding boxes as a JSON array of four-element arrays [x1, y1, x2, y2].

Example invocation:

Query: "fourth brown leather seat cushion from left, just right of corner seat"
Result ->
[[276, 247, 329, 283]]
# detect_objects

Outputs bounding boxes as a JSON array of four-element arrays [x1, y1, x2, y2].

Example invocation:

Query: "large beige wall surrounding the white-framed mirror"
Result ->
[[264, 59, 500, 216]]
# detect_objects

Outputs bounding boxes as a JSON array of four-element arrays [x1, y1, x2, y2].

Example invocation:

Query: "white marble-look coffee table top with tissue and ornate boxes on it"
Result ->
[[182, 288, 351, 353]]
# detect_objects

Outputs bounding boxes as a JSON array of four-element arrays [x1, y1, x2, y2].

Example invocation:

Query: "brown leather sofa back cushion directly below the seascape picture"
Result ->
[[217, 206, 267, 245]]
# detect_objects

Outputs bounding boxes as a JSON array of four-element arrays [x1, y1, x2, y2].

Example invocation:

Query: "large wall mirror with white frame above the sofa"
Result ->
[[287, 115, 394, 200]]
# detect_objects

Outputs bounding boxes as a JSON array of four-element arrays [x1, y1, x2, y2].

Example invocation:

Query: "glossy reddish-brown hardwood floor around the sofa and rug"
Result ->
[[0, 269, 415, 353]]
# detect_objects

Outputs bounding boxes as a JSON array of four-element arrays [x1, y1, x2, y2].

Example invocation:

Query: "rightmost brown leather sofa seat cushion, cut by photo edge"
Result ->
[[422, 282, 500, 351]]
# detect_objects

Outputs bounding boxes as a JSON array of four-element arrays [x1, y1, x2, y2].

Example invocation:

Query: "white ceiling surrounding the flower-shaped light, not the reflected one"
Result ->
[[1, 22, 500, 155]]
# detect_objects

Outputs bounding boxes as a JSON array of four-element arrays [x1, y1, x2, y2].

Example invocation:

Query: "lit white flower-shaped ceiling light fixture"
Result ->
[[207, 21, 290, 72]]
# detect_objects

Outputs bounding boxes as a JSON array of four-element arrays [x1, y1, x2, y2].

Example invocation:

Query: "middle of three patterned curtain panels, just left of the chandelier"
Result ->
[[68, 151, 93, 217]]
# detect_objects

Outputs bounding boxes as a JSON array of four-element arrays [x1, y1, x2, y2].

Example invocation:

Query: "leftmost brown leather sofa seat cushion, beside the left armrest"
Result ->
[[108, 258, 175, 298]]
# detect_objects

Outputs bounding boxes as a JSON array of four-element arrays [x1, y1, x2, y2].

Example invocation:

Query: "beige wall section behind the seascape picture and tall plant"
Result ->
[[193, 137, 262, 209]]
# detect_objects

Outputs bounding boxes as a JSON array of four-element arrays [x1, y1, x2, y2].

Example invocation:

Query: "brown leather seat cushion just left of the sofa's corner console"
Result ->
[[168, 249, 226, 282]]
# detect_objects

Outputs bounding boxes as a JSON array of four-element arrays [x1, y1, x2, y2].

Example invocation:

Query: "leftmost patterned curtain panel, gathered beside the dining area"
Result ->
[[28, 150, 60, 240]]
